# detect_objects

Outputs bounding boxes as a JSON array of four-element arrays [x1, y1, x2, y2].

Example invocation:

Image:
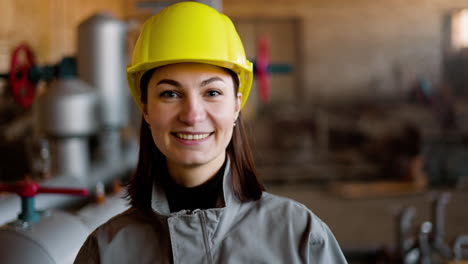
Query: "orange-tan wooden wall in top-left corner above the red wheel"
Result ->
[[0, 0, 126, 72]]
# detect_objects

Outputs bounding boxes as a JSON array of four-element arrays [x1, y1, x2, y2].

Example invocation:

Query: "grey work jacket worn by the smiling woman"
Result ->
[[74, 161, 347, 264]]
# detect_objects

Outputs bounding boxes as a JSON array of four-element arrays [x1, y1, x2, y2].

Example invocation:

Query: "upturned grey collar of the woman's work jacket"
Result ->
[[151, 155, 240, 216]]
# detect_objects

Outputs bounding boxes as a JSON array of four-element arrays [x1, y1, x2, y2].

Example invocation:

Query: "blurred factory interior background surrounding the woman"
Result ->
[[0, 0, 468, 264]]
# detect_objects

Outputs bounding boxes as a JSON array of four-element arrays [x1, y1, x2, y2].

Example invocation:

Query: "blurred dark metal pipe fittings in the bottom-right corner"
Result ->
[[343, 193, 468, 264]]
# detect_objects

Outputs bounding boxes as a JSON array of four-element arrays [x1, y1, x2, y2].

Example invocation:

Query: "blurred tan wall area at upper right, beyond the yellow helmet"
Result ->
[[223, 0, 468, 102]]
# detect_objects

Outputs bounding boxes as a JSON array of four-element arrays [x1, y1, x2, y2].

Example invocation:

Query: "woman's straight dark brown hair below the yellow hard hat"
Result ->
[[127, 66, 265, 212]]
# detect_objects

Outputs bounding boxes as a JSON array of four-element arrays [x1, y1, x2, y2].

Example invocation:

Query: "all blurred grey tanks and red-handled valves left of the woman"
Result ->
[[0, 10, 137, 264]]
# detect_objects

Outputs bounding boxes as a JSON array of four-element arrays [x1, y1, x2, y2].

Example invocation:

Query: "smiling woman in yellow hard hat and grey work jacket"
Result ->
[[75, 2, 346, 264]]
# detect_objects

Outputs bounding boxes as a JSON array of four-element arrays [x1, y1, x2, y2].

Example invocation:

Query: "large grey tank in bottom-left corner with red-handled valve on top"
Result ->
[[0, 180, 90, 264]]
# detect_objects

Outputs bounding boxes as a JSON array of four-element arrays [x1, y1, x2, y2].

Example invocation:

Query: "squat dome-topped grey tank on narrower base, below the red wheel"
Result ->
[[34, 73, 98, 178]]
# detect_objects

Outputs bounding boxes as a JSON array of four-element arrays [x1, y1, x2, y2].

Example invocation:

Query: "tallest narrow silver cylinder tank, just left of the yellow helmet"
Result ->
[[77, 13, 129, 163]]
